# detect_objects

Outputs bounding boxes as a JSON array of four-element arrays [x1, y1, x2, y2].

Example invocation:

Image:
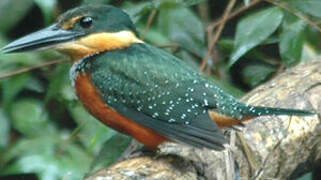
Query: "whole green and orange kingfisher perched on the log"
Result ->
[[2, 5, 313, 151]]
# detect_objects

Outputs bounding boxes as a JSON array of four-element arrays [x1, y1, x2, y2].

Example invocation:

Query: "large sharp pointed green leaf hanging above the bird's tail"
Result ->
[[229, 7, 283, 67]]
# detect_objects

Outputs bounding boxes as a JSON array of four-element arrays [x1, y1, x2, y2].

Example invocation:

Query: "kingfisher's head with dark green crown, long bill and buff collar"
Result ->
[[2, 5, 142, 61]]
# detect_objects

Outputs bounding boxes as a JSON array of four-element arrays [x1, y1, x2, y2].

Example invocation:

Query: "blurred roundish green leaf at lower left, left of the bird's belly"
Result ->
[[11, 99, 55, 136]]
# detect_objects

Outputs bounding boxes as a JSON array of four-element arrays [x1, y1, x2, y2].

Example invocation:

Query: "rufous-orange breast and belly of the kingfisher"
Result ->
[[75, 72, 167, 148]]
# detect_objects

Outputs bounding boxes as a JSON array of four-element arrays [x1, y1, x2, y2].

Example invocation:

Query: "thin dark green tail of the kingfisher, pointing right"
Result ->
[[243, 106, 315, 116]]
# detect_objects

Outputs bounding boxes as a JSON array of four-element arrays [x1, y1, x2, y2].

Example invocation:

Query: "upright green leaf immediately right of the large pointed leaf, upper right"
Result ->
[[279, 14, 307, 66]]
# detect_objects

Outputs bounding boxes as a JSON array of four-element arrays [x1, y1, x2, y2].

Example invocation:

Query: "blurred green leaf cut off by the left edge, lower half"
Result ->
[[0, 109, 10, 149]]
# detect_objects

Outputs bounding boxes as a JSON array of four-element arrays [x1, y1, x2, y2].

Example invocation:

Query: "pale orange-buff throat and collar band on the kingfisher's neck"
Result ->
[[57, 31, 144, 62]]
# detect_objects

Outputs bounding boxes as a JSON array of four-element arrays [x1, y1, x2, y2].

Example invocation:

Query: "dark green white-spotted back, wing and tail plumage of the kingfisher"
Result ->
[[71, 43, 310, 149]]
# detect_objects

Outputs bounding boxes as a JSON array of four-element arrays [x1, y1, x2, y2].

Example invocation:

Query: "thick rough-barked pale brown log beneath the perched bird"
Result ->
[[87, 59, 321, 180]]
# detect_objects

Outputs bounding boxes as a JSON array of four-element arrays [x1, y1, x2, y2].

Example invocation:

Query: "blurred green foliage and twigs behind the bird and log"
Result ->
[[0, 0, 321, 180]]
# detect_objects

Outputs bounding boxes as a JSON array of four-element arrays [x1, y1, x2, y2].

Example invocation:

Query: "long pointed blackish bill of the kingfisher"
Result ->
[[1, 24, 83, 53]]
